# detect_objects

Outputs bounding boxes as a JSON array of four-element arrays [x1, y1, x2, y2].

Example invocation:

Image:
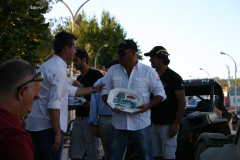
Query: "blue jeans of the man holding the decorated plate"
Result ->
[[108, 125, 154, 160]]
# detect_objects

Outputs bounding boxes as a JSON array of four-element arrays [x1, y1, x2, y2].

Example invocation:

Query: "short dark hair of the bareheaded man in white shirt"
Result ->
[[54, 31, 77, 54]]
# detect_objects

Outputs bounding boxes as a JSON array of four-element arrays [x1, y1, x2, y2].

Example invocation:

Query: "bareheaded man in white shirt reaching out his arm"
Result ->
[[26, 31, 104, 160]]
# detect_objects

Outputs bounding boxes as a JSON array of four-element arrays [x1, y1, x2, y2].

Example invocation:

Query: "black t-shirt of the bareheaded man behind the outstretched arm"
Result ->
[[76, 68, 103, 117]]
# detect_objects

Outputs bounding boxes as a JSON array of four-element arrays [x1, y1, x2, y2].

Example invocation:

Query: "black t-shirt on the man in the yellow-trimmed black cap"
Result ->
[[151, 68, 184, 124]]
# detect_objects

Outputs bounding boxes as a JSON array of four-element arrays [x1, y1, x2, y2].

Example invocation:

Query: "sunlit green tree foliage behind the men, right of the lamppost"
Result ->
[[53, 11, 143, 68]]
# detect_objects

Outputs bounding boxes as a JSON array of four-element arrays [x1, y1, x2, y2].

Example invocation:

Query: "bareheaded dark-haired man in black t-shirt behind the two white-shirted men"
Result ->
[[69, 49, 103, 160]]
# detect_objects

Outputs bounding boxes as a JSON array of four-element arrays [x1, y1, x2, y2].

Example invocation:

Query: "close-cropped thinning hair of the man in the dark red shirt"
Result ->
[[0, 59, 37, 94]]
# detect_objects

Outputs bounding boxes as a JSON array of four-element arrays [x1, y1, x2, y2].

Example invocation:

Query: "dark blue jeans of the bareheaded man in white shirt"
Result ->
[[28, 128, 64, 160]]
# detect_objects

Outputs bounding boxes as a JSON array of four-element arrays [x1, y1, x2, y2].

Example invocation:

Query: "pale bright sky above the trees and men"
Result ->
[[45, 0, 240, 79]]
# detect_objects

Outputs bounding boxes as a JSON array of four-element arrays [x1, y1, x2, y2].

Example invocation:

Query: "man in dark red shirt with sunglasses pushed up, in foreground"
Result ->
[[0, 59, 43, 160]]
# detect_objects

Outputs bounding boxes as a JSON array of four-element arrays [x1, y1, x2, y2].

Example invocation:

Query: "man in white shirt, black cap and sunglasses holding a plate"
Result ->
[[102, 40, 166, 160]]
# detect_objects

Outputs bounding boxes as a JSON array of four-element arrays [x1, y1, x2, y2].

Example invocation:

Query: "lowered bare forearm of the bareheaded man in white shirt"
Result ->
[[49, 109, 62, 152]]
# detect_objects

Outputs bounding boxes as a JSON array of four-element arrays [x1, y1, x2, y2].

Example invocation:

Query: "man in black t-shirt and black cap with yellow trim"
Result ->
[[144, 46, 186, 160]]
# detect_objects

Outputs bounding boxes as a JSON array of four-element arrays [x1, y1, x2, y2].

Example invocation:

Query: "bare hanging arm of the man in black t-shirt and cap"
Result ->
[[168, 90, 186, 138]]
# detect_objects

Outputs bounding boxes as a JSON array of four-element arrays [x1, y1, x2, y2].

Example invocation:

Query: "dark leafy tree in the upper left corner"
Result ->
[[0, 0, 51, 67]]
